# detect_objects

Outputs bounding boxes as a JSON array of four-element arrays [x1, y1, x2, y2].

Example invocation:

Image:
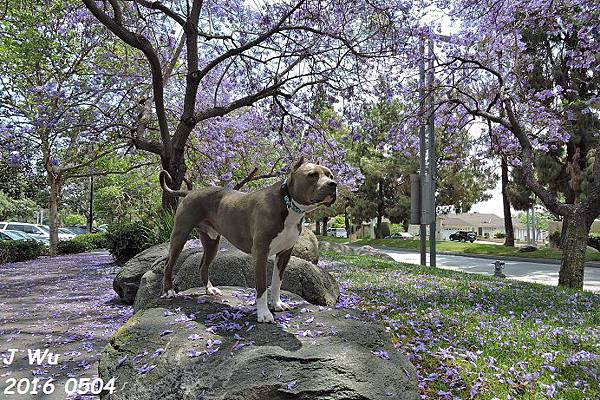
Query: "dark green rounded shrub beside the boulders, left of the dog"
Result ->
[[106, 222, 154, 263]]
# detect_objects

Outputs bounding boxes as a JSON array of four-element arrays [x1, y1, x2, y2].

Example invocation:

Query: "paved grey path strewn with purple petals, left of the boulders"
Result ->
[[0, 252, 132, 399]]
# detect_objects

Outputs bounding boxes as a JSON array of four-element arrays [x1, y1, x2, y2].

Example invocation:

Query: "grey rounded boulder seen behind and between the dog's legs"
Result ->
[[134, 249, 340, 311]]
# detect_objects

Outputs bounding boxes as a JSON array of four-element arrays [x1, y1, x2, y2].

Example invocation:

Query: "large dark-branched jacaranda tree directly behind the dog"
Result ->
[[83, 0, 418, 208]]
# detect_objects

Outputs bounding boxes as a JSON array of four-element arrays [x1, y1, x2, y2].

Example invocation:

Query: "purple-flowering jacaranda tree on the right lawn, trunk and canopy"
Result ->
[[423, 0, 600, 288]]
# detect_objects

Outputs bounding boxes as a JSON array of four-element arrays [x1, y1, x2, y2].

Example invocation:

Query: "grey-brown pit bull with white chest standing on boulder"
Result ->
[[160, 158, 337, 322]]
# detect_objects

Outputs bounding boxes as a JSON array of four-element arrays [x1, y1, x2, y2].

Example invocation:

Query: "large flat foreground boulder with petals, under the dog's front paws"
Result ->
[[99, 287, 418, 400]]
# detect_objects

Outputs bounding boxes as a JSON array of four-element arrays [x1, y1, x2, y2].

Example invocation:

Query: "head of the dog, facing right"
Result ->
[[288, 157, 337, 208]]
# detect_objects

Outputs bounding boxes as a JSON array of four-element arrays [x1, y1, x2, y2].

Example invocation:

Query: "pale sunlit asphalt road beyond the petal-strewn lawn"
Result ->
[[380, 249, 600, 292]]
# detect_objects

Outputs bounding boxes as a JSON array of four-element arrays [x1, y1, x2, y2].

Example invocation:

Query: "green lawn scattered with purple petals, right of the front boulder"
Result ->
[[321, 253, 600, 400]]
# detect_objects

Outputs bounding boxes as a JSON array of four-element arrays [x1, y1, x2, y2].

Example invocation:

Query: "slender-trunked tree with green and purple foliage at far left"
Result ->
[[0, 1, 142, 254]]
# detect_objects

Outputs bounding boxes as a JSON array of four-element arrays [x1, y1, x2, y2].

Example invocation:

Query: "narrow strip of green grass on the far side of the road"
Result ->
[[318, 236, 600, 261]]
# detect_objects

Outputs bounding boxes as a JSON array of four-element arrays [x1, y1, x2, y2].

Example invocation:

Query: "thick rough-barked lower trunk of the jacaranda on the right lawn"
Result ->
[[558, 211, 593, 289]]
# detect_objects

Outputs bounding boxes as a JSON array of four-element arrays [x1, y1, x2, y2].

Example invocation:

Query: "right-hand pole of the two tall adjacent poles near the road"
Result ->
[[427, 39, 437, 267]]
